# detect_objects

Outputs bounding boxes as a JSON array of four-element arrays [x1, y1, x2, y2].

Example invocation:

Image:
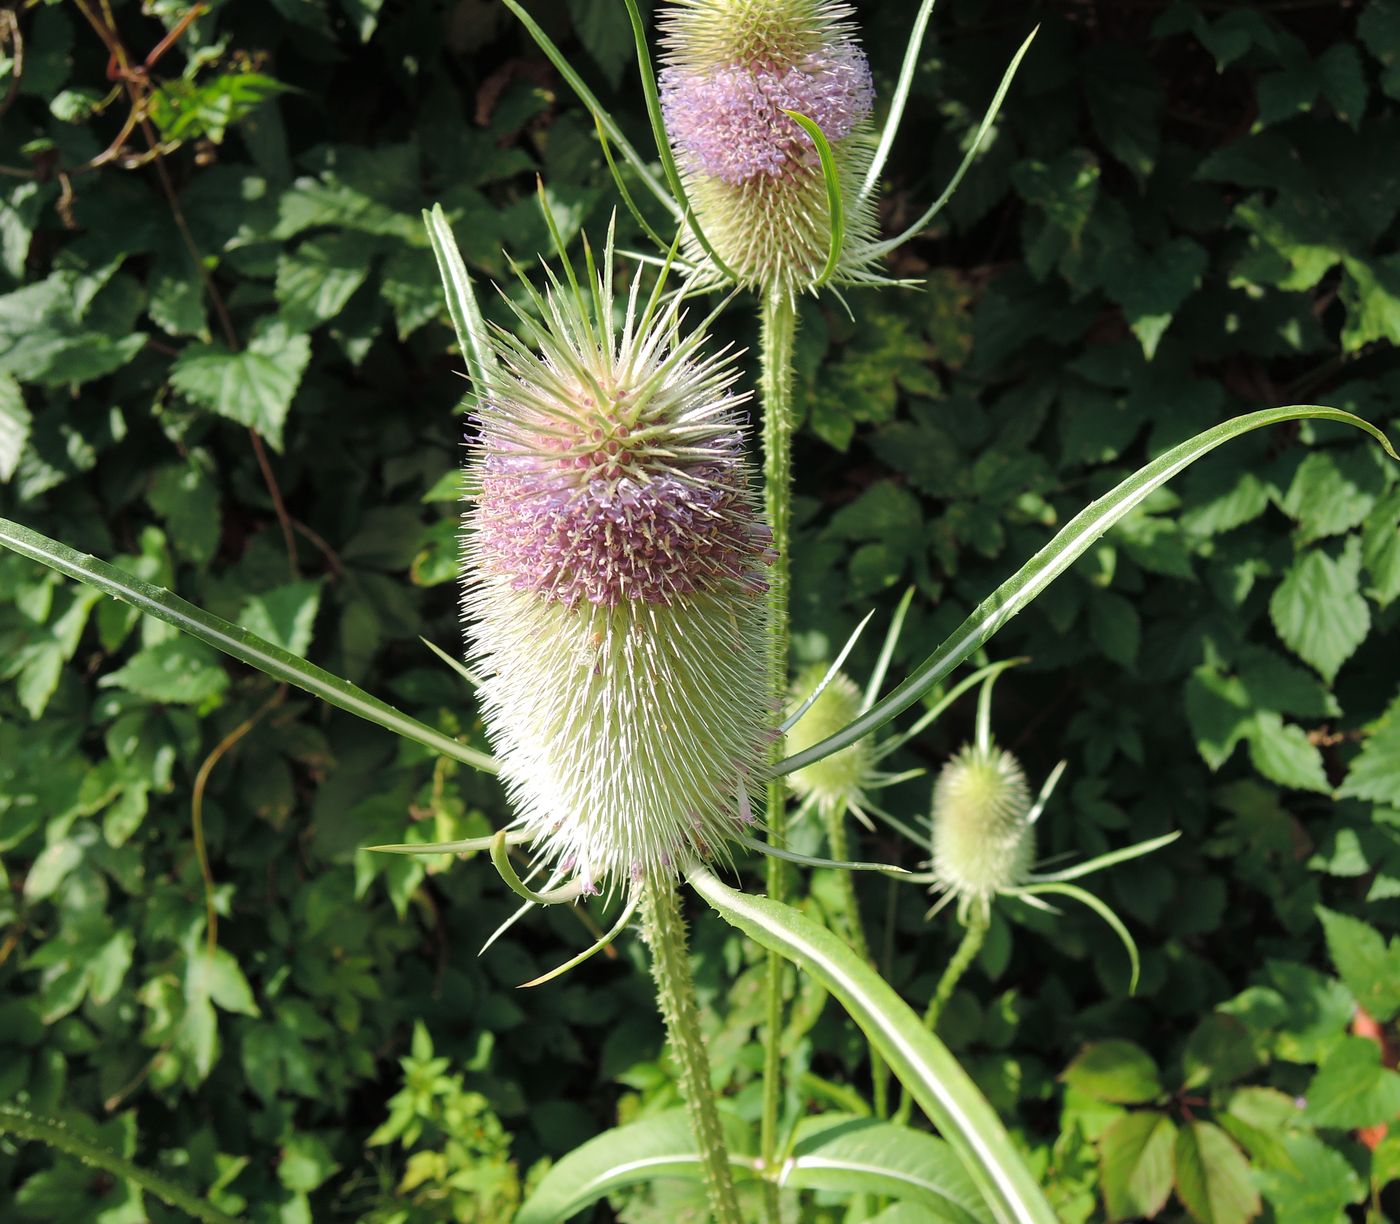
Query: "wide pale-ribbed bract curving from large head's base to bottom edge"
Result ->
[[686, 865, 1054, 1224]]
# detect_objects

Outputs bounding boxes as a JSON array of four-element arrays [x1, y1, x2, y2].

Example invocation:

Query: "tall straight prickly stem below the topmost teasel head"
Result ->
[[759, 286, 797, 1220]]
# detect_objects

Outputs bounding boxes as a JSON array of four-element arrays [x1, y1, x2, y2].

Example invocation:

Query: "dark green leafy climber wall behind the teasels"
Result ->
[[0, 0, 1400, 1224]]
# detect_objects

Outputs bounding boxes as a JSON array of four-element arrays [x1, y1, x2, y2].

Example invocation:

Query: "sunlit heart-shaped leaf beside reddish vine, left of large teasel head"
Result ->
[[171, 319, 311, 450]]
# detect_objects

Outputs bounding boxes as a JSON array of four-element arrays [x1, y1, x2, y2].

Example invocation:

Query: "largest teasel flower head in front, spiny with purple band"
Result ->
[[462, 249, 771, 891]]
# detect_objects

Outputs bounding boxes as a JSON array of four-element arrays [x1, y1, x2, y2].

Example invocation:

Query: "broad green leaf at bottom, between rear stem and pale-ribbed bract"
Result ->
[[783, 1113, 993, 1224]]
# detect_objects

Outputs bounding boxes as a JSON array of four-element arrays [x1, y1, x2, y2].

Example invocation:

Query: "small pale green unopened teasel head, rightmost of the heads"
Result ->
[[932, 744, 1035, 906]]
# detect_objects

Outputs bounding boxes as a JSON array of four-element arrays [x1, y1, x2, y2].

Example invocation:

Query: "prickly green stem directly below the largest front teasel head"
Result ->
[[641, 877, 742, 1224]]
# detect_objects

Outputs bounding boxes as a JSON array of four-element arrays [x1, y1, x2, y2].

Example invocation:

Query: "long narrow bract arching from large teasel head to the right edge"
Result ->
[[774, 405, 1400, 774]]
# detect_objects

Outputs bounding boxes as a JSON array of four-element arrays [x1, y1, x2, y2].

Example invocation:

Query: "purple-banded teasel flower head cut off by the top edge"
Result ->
[[659, 0, 876, 294]]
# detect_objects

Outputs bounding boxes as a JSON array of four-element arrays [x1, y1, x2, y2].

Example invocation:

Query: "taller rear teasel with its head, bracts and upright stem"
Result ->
[[505, 0, 1033, 1181]]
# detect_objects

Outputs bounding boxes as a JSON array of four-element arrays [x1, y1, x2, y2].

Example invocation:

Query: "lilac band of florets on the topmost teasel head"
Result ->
[[661, 38, 875, 183]]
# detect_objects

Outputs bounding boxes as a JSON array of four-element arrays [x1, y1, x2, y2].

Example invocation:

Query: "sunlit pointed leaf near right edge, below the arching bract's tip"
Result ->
[[1268, 536, 1371, 683]]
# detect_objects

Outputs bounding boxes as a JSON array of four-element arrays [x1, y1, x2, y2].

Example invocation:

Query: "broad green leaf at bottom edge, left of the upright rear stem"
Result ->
[[515, 1109, 755, 1224]]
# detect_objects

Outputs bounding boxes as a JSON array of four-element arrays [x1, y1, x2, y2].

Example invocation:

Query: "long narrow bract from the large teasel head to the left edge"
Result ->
[[0, 518, 496, 773]]
